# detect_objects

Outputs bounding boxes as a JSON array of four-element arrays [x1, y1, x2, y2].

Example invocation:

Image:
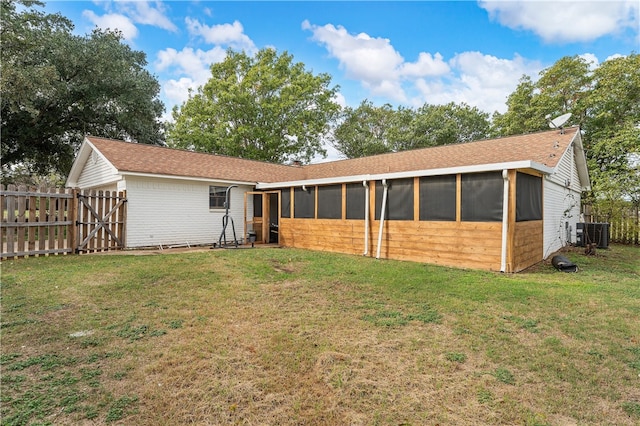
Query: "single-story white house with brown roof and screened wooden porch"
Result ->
[[67, 127, 590, 272]]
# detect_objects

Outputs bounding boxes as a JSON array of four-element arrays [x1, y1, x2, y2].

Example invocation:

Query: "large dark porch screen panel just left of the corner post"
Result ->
[[461, 172, 504, 222]]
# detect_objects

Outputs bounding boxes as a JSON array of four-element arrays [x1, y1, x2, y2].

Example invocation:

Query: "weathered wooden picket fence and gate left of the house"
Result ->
[[0, 185, 126, 259]]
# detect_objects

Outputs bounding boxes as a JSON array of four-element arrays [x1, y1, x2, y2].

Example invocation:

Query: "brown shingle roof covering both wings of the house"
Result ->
[[82, 128, 579, 183]]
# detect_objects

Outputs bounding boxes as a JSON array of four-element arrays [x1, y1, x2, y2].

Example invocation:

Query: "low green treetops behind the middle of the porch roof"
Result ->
[[333, 100, 489, 158]]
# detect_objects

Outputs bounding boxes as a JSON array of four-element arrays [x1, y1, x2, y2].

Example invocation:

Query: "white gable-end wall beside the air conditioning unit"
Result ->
[[543, 146, 581, 259]]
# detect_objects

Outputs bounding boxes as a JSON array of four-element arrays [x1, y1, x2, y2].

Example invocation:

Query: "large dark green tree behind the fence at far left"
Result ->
[[0, 0, 164, 180]]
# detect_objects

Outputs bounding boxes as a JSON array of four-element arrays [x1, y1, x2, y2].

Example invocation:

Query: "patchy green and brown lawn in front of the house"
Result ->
[[0, 246, 640, 425]]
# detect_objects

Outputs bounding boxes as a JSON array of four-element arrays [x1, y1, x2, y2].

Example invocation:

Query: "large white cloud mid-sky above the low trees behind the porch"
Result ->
[[302, 21, 542, 113]]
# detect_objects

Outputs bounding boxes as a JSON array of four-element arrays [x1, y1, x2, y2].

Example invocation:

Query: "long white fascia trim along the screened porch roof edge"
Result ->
[[256, 160, 553, 189]]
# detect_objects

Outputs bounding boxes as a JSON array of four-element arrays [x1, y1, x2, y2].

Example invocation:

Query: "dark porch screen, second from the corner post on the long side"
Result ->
[[420, 175, 456, 221]]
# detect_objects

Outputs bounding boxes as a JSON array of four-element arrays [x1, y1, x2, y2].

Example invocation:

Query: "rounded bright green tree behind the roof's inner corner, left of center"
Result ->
[[167, 49, 340, 163]]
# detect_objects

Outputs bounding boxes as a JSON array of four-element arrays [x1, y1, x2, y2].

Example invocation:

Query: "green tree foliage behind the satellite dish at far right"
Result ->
[[491, 53, 640, 211]]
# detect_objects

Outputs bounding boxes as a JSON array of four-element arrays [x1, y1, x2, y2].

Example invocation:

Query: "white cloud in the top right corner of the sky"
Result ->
[[479, 0, 640, 43]]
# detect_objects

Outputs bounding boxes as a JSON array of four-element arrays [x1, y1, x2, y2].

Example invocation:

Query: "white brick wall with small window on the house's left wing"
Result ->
[[126, 176, 251, 247]]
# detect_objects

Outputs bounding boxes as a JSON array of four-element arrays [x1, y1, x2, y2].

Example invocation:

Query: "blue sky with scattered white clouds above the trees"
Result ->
[[46, 0, 640, 122]]
